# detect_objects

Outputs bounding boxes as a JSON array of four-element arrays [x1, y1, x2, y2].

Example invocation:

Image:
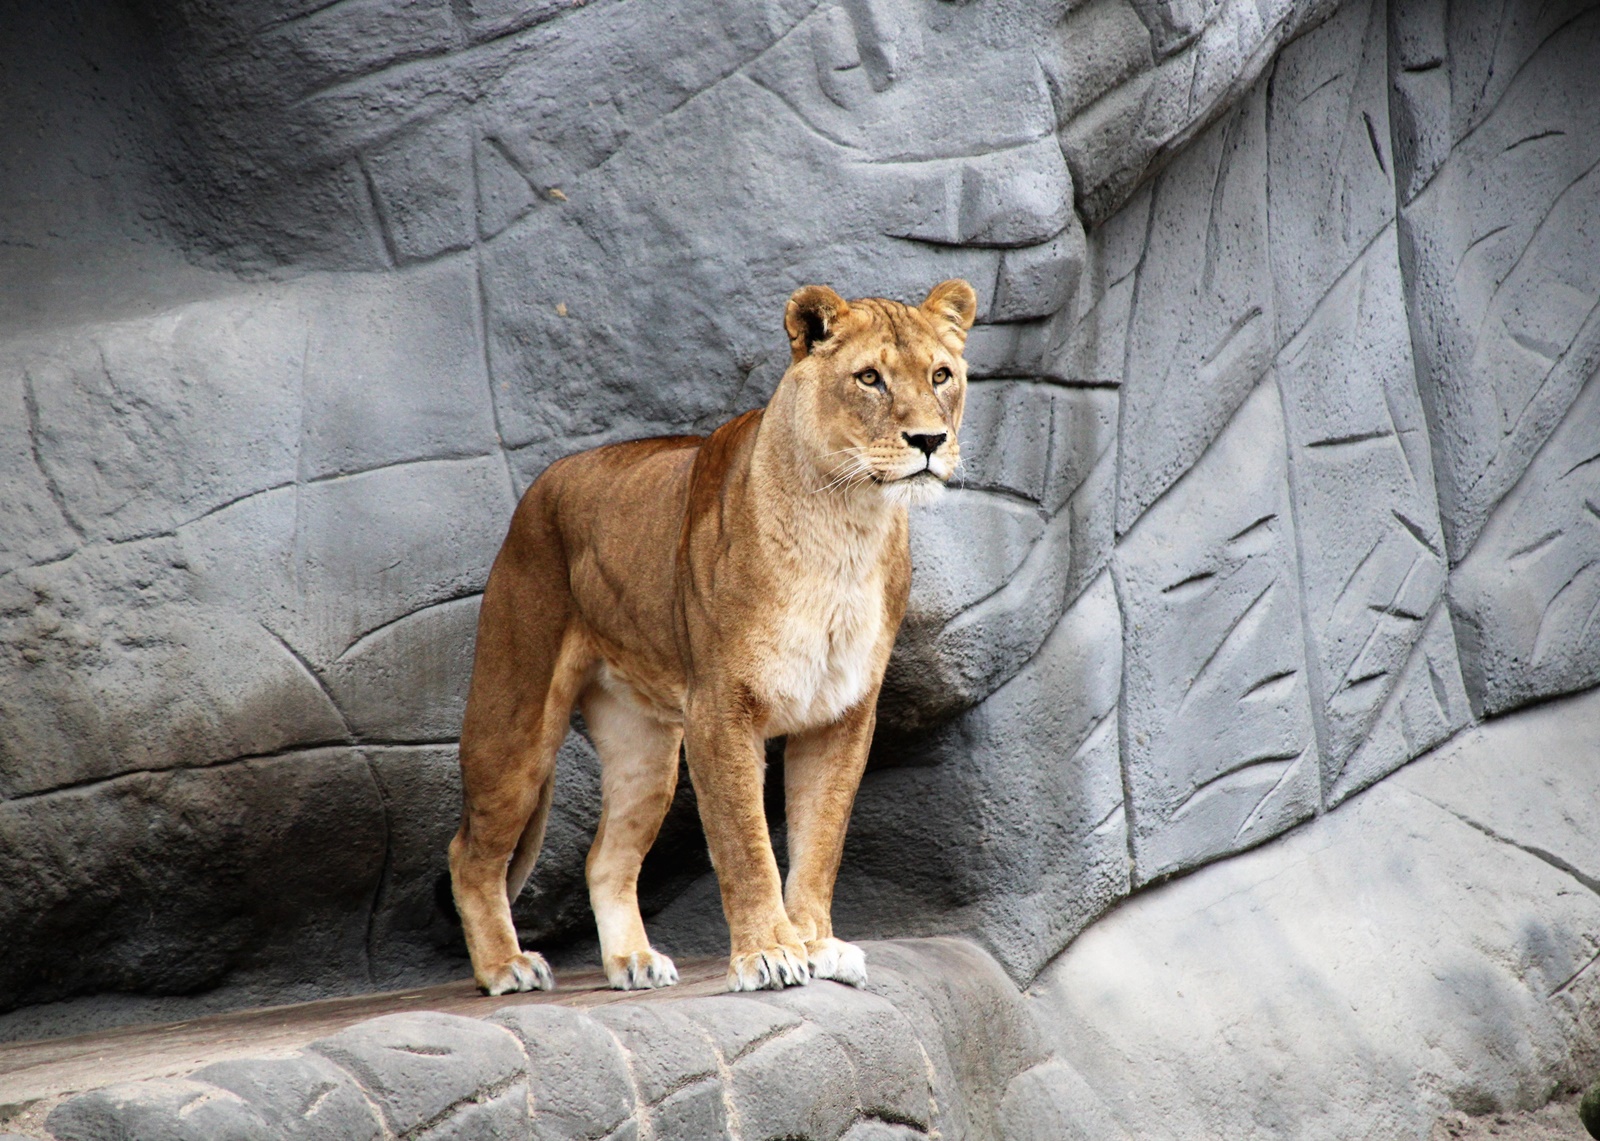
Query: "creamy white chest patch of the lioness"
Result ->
[[760, 579, 883, 736]]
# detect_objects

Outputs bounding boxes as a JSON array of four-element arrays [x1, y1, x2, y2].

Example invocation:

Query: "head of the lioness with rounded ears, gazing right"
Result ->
[[784, 280, 978, 502]]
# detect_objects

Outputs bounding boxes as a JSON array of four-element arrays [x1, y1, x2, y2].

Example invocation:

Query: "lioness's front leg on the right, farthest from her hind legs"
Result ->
[[784, 693, 877, 986]]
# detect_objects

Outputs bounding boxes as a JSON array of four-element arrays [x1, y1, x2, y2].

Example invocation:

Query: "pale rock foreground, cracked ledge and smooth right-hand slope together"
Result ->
[[21, 691, 1600, 1141]]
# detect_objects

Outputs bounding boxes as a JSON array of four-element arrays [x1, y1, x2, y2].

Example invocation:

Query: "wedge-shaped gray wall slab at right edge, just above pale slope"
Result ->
[[1450, 358, 1600, 714]]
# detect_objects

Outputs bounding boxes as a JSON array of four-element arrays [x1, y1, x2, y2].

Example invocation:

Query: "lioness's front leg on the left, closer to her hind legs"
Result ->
[[683, 695, 811, 991]]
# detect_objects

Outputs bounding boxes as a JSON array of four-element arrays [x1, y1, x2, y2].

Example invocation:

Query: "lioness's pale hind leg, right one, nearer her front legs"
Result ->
[[581, 682, 683, 991]]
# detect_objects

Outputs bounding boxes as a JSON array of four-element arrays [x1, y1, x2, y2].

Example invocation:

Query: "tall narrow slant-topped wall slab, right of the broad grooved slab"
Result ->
[[1275, 229, 1467, 791]]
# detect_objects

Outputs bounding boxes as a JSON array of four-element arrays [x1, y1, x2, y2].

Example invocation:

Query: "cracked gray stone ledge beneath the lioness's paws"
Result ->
[[40, 939, 1043, 1141]]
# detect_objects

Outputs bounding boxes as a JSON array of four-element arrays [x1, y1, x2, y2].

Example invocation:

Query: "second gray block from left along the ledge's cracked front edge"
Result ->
[[188, 1055, 382, 1141]]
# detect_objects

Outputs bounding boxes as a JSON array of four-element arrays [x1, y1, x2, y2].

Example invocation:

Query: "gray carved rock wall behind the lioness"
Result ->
[[0, 0, 1600, 1032]]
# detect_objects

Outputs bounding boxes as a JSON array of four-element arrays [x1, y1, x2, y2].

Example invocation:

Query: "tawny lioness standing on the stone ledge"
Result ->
[[450, 280, 976, 994]]
